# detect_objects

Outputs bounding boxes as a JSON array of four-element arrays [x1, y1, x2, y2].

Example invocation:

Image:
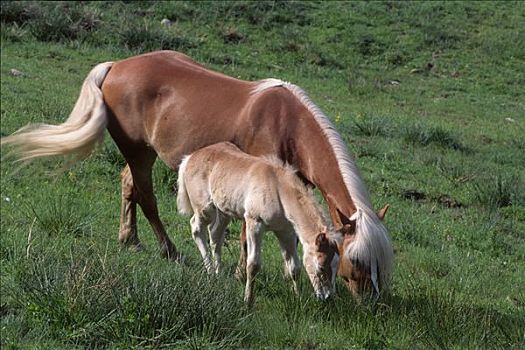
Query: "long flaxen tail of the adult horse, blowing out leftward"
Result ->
[[1, 62, 113, 160]]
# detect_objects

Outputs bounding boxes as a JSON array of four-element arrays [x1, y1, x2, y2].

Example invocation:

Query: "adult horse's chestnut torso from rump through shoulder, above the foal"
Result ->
[[102, 51, 314, 174]]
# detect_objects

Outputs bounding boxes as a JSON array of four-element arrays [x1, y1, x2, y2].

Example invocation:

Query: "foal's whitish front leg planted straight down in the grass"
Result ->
[[244, 217, 263, 304]]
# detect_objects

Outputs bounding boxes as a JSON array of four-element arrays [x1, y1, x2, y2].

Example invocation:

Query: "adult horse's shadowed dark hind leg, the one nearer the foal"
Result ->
[[123, 151, 180, 260]]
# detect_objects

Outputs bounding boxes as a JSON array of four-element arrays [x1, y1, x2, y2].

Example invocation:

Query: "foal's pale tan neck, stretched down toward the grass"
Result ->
[[279, 174, 327, 245]]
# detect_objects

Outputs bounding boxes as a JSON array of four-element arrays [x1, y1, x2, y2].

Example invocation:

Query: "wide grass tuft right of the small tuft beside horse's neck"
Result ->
[[402, 125, 466, 150]]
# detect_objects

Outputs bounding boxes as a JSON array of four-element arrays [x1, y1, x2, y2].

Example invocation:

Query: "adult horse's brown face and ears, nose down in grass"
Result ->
[[337, 204, 389, 299]]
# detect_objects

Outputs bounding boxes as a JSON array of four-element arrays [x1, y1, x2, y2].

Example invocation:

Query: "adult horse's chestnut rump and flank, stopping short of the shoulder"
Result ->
[[102, 51, 254, 168]]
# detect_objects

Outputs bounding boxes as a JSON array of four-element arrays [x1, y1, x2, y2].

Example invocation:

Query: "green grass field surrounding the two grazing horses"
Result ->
[[0, 1, 525, 350]]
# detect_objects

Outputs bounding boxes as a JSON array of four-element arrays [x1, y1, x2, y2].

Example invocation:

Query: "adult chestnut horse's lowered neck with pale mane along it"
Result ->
[[245, 80, 369, 228]]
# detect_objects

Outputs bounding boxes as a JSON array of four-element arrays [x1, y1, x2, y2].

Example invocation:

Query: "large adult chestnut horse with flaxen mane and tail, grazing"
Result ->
[[1, 51, 393, 294]]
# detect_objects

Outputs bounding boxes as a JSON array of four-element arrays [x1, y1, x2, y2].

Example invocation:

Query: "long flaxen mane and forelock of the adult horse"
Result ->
[[252, 79, 393, 286]]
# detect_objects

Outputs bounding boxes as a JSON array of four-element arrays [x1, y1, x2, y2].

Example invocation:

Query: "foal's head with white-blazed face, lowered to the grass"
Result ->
[[303, 233, 339, 300]]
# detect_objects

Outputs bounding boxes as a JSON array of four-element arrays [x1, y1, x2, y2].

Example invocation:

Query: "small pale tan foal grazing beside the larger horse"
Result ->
[[177, 142, 340, 303]]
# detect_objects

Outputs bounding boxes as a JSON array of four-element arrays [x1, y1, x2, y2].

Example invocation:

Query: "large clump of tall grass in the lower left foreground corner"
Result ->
[[9, 254, 248, 348]]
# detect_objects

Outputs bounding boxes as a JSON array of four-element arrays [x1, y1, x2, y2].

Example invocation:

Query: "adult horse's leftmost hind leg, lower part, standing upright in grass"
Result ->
[[118, 164, 142, 251]]
